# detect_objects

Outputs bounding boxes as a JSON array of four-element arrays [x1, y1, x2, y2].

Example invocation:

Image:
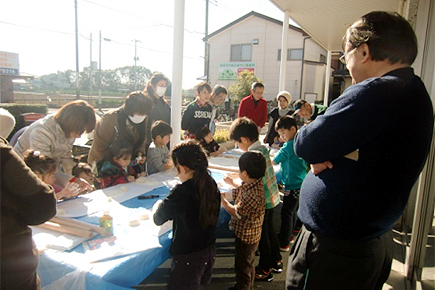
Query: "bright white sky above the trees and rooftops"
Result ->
[[0, 0, 284, 89]]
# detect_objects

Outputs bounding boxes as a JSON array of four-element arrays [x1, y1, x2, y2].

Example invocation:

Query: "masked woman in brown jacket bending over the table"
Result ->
[[88, 92, 153, 170]]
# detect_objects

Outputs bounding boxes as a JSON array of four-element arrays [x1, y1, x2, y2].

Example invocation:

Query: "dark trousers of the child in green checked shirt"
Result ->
[[258, 208, 282, 271]]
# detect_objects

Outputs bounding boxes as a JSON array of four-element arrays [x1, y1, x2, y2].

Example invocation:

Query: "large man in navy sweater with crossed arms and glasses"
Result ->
[[286, 12, 434, 290]]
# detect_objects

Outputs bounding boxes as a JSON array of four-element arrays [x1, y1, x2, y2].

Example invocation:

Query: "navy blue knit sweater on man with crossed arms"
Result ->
[[294, 68, 434, 240]]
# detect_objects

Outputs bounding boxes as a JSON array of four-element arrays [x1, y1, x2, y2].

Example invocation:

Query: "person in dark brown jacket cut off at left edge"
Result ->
[[0, 137, 56, 290]]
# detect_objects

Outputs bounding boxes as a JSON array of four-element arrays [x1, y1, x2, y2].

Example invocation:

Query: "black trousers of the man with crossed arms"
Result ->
[[286, 226, 393, 290]]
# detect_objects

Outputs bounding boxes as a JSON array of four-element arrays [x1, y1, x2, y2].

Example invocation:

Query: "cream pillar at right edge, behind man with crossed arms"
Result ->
[[404, 0, 435, 289]]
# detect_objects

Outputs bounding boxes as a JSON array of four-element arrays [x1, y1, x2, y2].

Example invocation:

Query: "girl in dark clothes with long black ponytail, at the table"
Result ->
[[153, 141, 221, 289]]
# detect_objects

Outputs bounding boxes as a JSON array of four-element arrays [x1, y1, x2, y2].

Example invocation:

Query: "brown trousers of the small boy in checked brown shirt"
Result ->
[[235, 237, 258, 290]]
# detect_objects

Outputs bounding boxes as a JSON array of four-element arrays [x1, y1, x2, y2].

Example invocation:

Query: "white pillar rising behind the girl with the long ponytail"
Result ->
[[171, 0, 185, 149]]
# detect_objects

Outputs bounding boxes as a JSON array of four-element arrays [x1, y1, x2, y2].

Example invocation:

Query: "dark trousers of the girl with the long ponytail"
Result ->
[[168, 245, 216, 290]]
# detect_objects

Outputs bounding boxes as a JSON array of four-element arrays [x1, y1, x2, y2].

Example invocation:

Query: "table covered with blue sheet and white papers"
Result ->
[[33, 169, 230, 290]]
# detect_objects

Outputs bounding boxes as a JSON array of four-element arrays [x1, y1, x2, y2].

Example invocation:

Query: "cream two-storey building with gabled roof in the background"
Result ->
[[205, 12, 327, 102]]
